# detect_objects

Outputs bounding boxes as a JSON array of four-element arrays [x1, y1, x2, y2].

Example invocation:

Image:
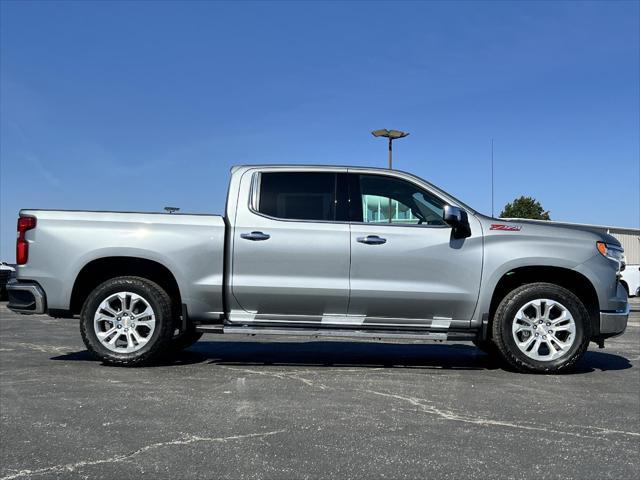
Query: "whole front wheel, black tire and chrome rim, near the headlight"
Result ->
[[492, 283, 591, 373]]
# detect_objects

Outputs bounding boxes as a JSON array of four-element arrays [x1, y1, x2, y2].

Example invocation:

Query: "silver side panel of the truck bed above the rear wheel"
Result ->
[[17, 210, 225, 321]]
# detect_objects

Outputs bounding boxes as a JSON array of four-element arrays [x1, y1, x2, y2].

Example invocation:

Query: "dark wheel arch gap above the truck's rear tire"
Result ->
[[69, 256, 182, 314]]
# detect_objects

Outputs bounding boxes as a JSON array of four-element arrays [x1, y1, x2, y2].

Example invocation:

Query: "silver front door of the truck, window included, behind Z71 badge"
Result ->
[[349, 173, 482, 326]]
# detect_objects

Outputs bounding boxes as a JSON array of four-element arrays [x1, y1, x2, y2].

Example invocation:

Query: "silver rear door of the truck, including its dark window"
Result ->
[[230, 168, 350, 324]]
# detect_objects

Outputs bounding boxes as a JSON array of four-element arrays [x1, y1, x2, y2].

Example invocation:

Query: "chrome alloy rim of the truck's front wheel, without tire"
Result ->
[[511, 298, 576, 361]]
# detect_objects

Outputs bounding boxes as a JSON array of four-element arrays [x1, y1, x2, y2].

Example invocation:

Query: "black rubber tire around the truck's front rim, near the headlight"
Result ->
[[492, 282, 591, 373]]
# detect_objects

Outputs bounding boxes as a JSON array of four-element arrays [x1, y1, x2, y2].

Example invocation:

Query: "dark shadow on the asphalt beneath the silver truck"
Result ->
[[52, 341, 633, 374]]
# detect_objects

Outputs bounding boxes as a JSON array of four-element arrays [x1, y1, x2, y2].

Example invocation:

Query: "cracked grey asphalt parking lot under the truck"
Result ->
[[0, 302, 640, 480]]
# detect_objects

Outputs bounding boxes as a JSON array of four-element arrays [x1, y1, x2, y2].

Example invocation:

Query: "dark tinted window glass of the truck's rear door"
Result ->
[[258, 172, 336, 220]]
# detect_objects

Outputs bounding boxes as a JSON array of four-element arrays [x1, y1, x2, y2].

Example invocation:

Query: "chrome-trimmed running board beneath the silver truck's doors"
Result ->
[[196, 325, 476, 341]]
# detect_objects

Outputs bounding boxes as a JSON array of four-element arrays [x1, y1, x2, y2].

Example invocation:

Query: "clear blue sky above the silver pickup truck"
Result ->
[[0, 1, 640, 261]]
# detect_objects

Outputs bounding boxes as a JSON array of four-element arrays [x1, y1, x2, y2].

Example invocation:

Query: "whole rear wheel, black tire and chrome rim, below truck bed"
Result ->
[[80, 277, 174, 366]]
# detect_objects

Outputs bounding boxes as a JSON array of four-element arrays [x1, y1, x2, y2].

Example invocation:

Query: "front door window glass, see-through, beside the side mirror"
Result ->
[[359, 175, 445, 225]]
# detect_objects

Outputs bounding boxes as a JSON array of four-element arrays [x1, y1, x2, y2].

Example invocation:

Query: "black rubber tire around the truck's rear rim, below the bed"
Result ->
[[80, 277, 175, 366]]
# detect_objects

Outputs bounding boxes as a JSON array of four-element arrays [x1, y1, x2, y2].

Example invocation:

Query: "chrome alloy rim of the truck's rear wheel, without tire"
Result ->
[[93, 292, 156, 353]]
